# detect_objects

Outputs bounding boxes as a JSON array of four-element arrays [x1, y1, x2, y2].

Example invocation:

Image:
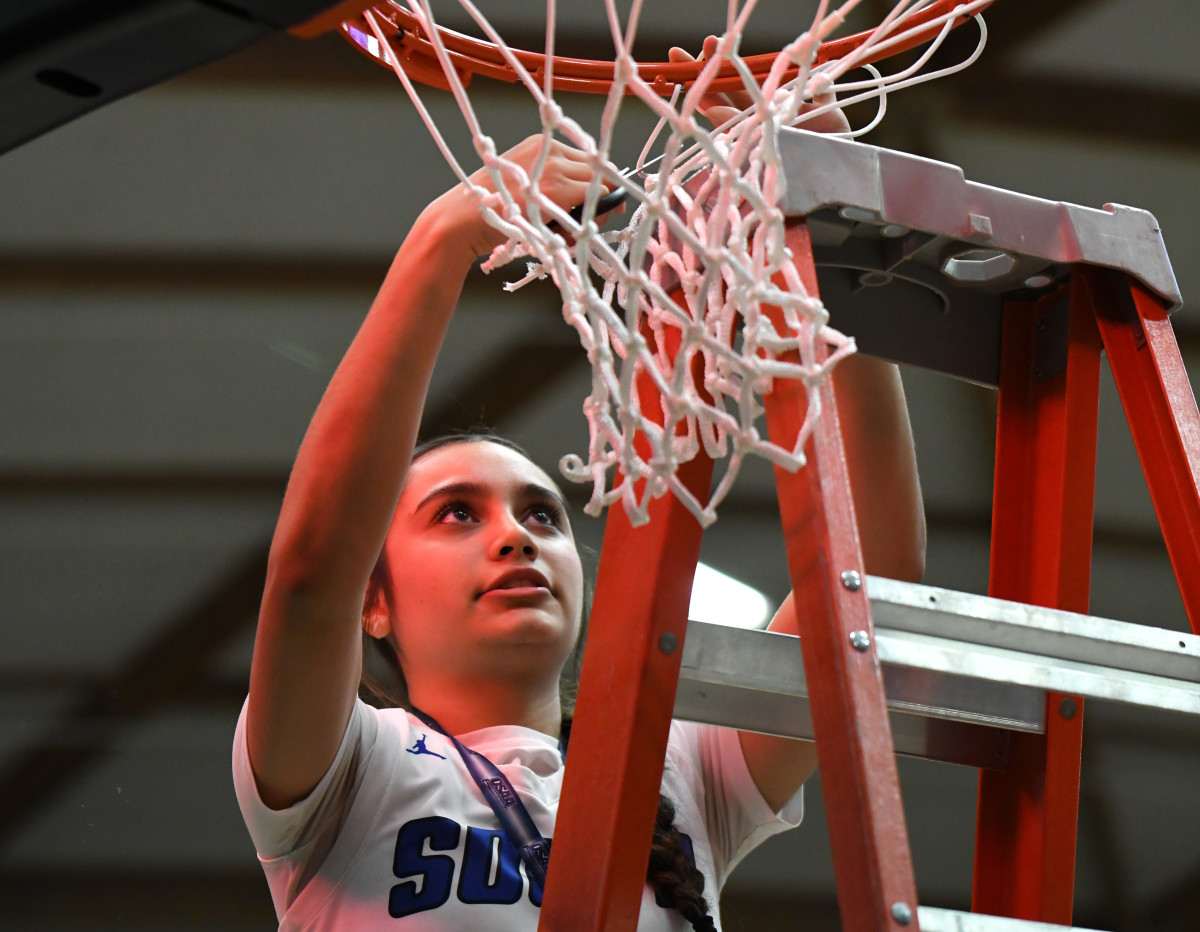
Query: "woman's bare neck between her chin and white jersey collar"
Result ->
[[408, 680, 563, 738]]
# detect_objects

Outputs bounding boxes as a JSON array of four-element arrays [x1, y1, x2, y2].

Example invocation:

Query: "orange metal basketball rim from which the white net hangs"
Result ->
[[342, 0, 985, 96]]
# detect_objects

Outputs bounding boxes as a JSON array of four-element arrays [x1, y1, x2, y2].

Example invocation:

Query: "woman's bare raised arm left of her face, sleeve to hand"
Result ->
[[246, 137, 604, 808]]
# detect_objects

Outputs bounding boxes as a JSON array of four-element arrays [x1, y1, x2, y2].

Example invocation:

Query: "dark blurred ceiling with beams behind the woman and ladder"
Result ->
[[0, 0, 1200, 932]]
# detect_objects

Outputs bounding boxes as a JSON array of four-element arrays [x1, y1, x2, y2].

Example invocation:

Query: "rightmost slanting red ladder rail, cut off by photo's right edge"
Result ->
[[1084, 269, 1200, 633]]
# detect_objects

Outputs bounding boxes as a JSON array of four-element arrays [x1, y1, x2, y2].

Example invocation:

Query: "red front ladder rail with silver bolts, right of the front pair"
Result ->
[[764, 221, 917, 932]]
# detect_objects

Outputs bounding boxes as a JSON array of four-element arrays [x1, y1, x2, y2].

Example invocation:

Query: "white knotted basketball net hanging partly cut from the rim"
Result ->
[[346, 0, 990, 527]]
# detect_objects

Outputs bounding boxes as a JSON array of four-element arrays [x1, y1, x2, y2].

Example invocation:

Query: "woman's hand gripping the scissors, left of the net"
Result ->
[[426, 133, 613, 261]]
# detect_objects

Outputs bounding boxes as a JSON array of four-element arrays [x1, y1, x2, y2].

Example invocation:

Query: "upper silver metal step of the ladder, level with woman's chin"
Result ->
[[674, 577, 1200, 768]]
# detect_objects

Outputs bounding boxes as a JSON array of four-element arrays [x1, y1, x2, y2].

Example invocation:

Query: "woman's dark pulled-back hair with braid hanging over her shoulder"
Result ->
[[359, 432, 716, 932]]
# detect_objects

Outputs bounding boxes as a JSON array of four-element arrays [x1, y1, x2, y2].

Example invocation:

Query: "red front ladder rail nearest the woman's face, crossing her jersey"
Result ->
[[538, 321, 713, 932]]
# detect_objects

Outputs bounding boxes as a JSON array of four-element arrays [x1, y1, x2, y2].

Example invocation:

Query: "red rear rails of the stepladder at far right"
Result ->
[[972, 266, 1200, 925]]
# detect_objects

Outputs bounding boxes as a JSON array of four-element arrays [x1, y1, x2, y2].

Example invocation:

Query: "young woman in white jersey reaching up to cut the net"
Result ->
[[234, 125, 924, 932]]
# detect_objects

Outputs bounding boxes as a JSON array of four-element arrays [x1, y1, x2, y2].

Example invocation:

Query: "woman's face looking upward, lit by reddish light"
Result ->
[[385, 440, 583, 683]]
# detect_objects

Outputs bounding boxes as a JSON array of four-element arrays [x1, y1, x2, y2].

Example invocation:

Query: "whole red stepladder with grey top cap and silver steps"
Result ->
[[540, 131, 1200, 932]]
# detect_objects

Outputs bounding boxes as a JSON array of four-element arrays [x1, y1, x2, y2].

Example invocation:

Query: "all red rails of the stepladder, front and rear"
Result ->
[[539, 215, 1200, 932]]
